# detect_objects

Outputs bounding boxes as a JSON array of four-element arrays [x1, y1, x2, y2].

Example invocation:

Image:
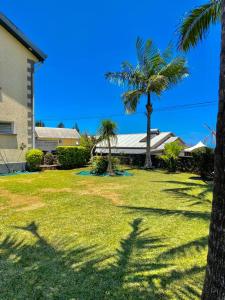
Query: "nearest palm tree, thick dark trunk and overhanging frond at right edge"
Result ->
[[179, 0, 225, 300]]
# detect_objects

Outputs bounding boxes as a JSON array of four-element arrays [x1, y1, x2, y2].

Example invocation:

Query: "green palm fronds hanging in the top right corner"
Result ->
[[178, 0, 222, 51]]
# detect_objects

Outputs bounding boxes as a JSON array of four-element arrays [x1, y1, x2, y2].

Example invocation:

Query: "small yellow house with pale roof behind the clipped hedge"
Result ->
[[35, 127, 80, 152]]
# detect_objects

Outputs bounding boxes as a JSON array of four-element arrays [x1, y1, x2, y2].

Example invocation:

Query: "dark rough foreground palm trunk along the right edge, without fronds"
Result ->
[[202, 0, 225, 300]]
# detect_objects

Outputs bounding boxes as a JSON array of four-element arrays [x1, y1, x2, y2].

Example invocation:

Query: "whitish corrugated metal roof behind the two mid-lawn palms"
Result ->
[[97, 132, 172, 149]]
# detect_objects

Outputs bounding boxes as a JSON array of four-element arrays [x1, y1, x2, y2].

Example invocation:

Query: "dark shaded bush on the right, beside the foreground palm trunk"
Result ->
[[192, 148, 214, 180]]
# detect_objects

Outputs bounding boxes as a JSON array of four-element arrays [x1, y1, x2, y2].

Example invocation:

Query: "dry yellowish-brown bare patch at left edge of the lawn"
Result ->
[[0, 189, 45, 211]]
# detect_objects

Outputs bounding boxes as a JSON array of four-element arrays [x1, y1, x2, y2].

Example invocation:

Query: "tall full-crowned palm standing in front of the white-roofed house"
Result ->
[[106, 38, 188, 169]]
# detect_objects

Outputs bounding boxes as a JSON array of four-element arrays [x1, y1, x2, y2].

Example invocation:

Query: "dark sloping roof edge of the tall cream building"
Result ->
[[0, 13, 47, 62]]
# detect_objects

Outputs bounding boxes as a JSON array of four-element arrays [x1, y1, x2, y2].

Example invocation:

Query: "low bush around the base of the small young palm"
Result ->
[[91, 156, 119, 175]]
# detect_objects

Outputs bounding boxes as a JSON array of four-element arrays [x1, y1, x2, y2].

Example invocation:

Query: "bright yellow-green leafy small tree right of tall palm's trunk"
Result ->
[[161, 141, 183, 172]]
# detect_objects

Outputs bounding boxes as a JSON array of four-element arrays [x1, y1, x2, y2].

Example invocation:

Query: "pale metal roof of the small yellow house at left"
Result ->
[[35, 127, 80, 139]]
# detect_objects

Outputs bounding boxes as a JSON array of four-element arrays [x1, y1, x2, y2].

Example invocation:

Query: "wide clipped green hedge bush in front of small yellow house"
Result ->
[[56, 146, 89, 170]]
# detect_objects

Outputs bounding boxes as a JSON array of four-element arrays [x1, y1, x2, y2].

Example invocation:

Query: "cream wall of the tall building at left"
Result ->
[[0, 26, 37, 163]]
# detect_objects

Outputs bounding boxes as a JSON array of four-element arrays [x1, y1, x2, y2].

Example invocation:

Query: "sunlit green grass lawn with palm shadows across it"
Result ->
[[0, 170, 211, 300]]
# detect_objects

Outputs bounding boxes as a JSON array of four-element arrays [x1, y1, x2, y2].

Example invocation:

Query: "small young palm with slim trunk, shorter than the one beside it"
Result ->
[[98, 120, 117, 176]]
